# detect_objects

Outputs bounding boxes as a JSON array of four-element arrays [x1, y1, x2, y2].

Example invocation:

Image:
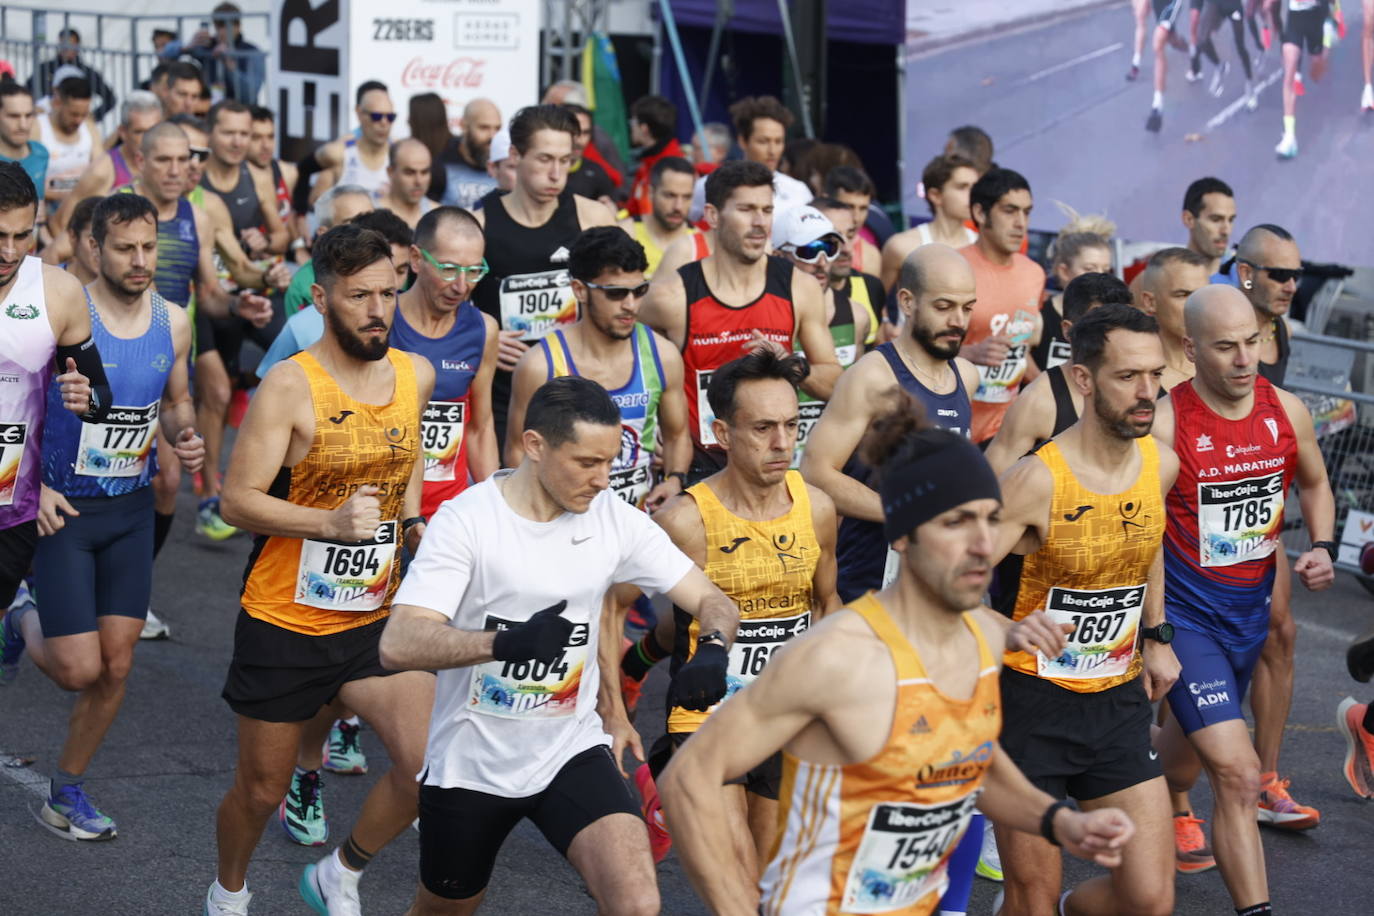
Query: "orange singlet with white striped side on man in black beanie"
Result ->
[[758, 592, 1002, 916]]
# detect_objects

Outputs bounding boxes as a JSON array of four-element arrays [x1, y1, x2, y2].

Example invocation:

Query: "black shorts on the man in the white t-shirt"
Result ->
[[420, 744, 640, 900]]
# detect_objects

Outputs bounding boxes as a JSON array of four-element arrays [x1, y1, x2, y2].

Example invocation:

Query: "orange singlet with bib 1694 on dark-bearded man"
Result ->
[[242, 350, 420, 636]]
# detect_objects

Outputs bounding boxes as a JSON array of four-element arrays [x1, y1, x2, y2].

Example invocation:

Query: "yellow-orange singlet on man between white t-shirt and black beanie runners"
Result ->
[[668, 471, 820, 732]]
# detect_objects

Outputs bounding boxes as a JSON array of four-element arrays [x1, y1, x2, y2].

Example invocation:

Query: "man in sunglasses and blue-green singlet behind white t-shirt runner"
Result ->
[[506, 225, 691, 511]]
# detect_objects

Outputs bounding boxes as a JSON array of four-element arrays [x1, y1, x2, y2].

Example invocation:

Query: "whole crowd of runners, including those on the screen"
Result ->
[[0, 0, 1374, 916]]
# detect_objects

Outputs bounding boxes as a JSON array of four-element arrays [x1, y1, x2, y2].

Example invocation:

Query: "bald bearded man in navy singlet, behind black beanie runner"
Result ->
[[801, 244, 978, 602]]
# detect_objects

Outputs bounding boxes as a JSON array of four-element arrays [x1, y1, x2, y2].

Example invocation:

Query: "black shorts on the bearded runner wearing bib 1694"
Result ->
[[220, 608, 396, 722]]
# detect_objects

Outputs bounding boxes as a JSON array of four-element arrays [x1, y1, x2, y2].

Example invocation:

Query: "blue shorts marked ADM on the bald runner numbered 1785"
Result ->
[[1169, 628, 1264, 735]]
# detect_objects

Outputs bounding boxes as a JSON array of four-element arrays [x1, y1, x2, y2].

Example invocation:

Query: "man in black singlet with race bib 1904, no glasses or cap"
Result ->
[[473, 104, 614, 445]]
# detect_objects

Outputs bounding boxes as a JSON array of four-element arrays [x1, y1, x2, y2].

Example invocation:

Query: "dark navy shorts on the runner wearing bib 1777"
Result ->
[[33, 486, 153, 639]]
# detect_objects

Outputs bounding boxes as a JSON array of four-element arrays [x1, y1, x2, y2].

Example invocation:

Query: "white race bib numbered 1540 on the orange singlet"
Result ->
[[840, 791, 978, 913]]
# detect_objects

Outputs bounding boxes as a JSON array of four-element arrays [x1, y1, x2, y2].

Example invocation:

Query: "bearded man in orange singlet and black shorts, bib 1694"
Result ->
[[205, 225, 434, 916]]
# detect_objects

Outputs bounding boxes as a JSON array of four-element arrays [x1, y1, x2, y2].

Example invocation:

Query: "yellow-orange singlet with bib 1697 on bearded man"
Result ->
[[1006, 435, 1164, 694]]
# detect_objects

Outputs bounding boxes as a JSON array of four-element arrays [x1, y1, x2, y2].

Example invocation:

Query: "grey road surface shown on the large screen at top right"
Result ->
[[905, 3, 1374, 265]]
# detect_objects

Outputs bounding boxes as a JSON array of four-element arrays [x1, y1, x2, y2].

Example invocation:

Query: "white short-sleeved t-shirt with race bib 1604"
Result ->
[[396, 471, 692, 798]]
